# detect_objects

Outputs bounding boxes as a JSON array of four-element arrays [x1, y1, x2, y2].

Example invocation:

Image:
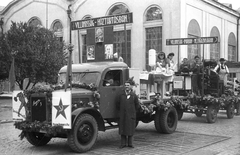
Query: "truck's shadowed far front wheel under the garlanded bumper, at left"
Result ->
[[25, 132, 52, 146]]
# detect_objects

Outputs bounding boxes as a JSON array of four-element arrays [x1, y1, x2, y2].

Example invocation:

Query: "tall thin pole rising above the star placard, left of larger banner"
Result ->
[[65, 4, 73, 91]]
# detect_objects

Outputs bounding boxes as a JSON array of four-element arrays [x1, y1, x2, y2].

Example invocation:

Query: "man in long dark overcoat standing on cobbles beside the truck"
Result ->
[[116, 79, 140, 148]]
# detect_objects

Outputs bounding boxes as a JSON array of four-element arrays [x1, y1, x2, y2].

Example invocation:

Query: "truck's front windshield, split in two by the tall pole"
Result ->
[[58, 72, 100, 85]]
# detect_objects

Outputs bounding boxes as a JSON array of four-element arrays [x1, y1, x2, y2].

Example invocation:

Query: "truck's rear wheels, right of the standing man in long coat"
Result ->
[[154, 107, 178, 134]]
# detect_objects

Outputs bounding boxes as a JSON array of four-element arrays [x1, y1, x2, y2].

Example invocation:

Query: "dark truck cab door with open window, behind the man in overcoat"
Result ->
[[99, 68, 125, 119]]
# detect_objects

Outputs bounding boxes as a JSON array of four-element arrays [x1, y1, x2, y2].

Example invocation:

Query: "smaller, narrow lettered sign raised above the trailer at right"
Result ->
[[166, 37, 218, 45]]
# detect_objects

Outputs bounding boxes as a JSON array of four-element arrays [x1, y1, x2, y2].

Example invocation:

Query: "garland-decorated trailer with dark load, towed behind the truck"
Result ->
[[173, 60, 240, 123]]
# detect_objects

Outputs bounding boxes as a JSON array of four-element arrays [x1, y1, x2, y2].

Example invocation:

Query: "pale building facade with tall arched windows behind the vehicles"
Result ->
[[0, 0, 240, 70]]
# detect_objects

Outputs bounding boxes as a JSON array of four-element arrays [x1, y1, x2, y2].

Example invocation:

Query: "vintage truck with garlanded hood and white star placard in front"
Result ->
[[15, 62, 178, 152]]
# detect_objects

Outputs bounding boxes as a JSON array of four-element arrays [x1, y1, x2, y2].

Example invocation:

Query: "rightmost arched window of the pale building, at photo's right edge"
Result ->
[[228, 33, 237, 61]]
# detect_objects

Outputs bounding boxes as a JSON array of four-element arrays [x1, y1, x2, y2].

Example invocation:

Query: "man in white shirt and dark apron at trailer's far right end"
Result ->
[[214, 58, 229, 86]]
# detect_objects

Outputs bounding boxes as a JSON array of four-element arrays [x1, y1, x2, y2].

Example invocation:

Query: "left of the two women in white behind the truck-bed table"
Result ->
[[156, 52, 170, 72]]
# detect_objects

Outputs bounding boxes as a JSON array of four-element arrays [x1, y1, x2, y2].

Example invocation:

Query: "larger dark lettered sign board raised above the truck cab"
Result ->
[[71, 13, 133, 30]]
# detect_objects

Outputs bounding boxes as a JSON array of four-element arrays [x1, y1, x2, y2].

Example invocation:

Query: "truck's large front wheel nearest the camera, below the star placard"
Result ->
[[68, 114, 98, 153]]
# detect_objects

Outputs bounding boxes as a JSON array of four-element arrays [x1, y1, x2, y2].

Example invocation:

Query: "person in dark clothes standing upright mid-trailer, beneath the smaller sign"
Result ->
[[191, 56, 203, 95]]
